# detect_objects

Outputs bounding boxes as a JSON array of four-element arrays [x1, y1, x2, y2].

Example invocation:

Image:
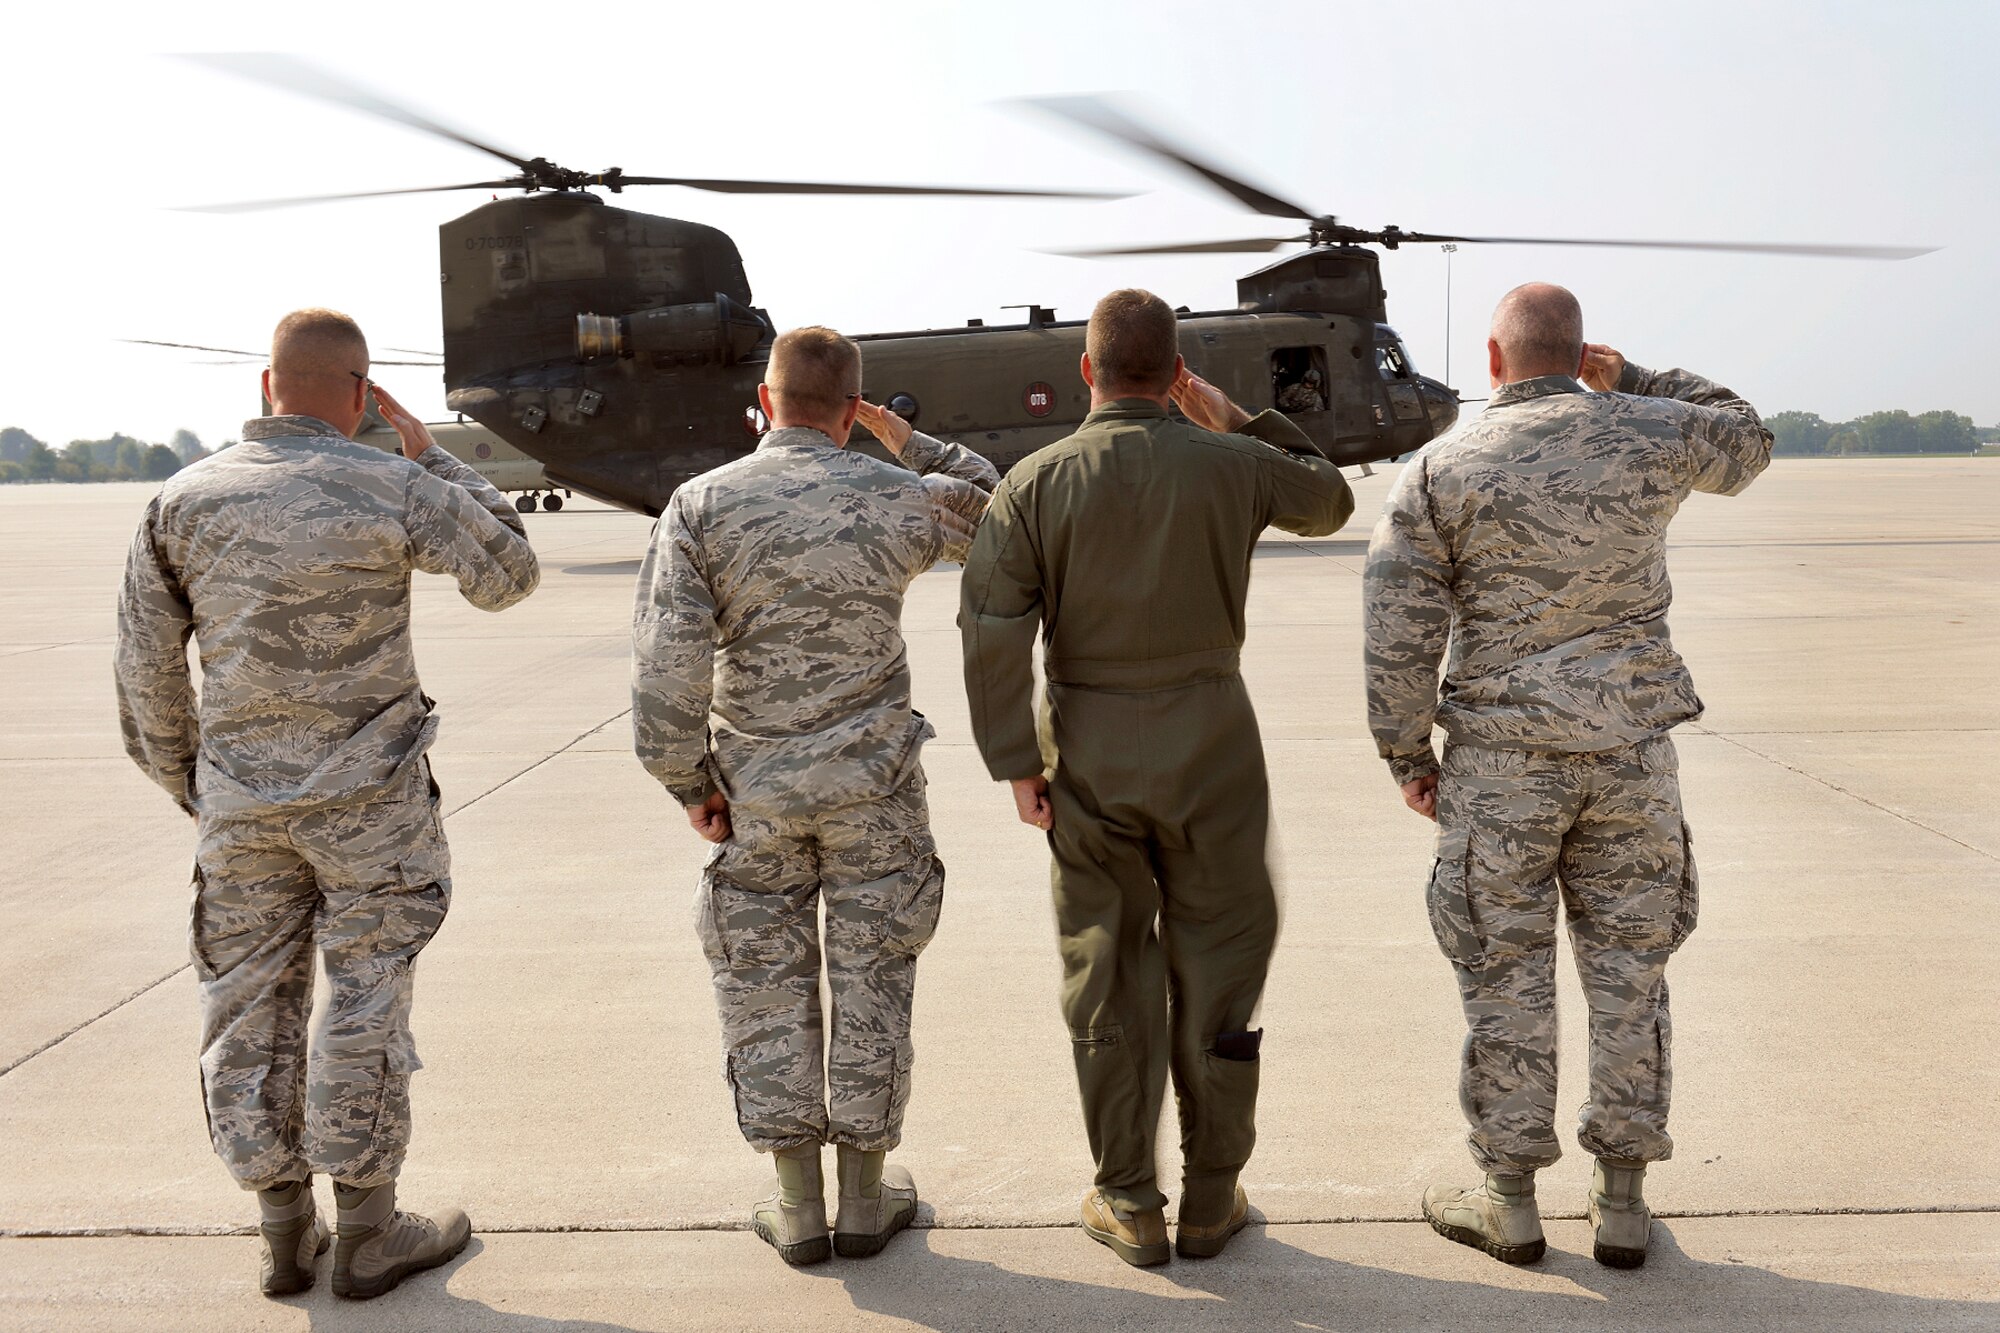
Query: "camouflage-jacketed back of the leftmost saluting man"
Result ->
[[129, 416, 536, 813]]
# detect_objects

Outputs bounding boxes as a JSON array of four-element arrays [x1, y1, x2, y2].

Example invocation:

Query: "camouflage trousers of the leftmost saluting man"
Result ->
[[190, 780, 452, 1189]]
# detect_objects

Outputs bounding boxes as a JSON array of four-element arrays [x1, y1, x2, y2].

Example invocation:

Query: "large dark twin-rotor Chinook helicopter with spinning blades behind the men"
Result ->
[[202, 56, 1924, 514]]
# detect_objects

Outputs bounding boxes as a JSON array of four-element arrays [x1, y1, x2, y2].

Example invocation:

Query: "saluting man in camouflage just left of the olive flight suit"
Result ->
[[632, 328, 998, 1263]]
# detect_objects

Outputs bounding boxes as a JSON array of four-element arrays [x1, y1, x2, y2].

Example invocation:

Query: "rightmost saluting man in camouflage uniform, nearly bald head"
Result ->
[[1366, 284, 1770, 1267]]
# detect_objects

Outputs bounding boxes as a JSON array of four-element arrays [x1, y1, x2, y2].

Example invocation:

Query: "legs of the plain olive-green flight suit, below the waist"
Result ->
[[1046, 675, 1278, 1211]]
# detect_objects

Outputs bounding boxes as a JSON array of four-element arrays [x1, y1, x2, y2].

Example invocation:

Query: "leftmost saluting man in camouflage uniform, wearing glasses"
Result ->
[[116, 310, 540, 1297]]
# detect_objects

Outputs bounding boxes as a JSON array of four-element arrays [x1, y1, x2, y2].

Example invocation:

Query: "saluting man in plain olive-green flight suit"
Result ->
[[958, 290, 1354, 1265]]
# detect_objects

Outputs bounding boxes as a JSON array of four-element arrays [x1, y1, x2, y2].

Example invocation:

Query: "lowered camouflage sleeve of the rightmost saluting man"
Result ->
[[1362, 454, 1452, 785]]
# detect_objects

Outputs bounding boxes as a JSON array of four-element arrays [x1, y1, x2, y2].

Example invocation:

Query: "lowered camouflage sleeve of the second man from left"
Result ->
[[632, 492, 718, 805]]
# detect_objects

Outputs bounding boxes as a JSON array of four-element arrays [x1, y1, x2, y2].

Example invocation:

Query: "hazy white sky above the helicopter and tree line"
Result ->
[[0, 0, 2000, 444]]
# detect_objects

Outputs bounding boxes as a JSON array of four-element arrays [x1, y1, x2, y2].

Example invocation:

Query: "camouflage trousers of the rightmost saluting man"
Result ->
[[1426, 737, 1698, 1175]]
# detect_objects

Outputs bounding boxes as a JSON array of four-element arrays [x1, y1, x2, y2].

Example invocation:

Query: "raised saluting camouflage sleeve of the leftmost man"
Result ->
[[404, 444, 542, 610]]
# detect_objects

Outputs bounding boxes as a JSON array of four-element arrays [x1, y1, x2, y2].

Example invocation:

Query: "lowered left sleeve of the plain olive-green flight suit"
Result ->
[[958, 482, 1042, 783]]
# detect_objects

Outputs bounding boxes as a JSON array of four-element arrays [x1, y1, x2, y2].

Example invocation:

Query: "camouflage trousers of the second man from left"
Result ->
[[694, 771, 944, 1153]]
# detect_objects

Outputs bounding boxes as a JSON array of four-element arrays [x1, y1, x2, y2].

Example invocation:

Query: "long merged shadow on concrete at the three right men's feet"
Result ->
[[826, 1223, 2000, 1333]]
